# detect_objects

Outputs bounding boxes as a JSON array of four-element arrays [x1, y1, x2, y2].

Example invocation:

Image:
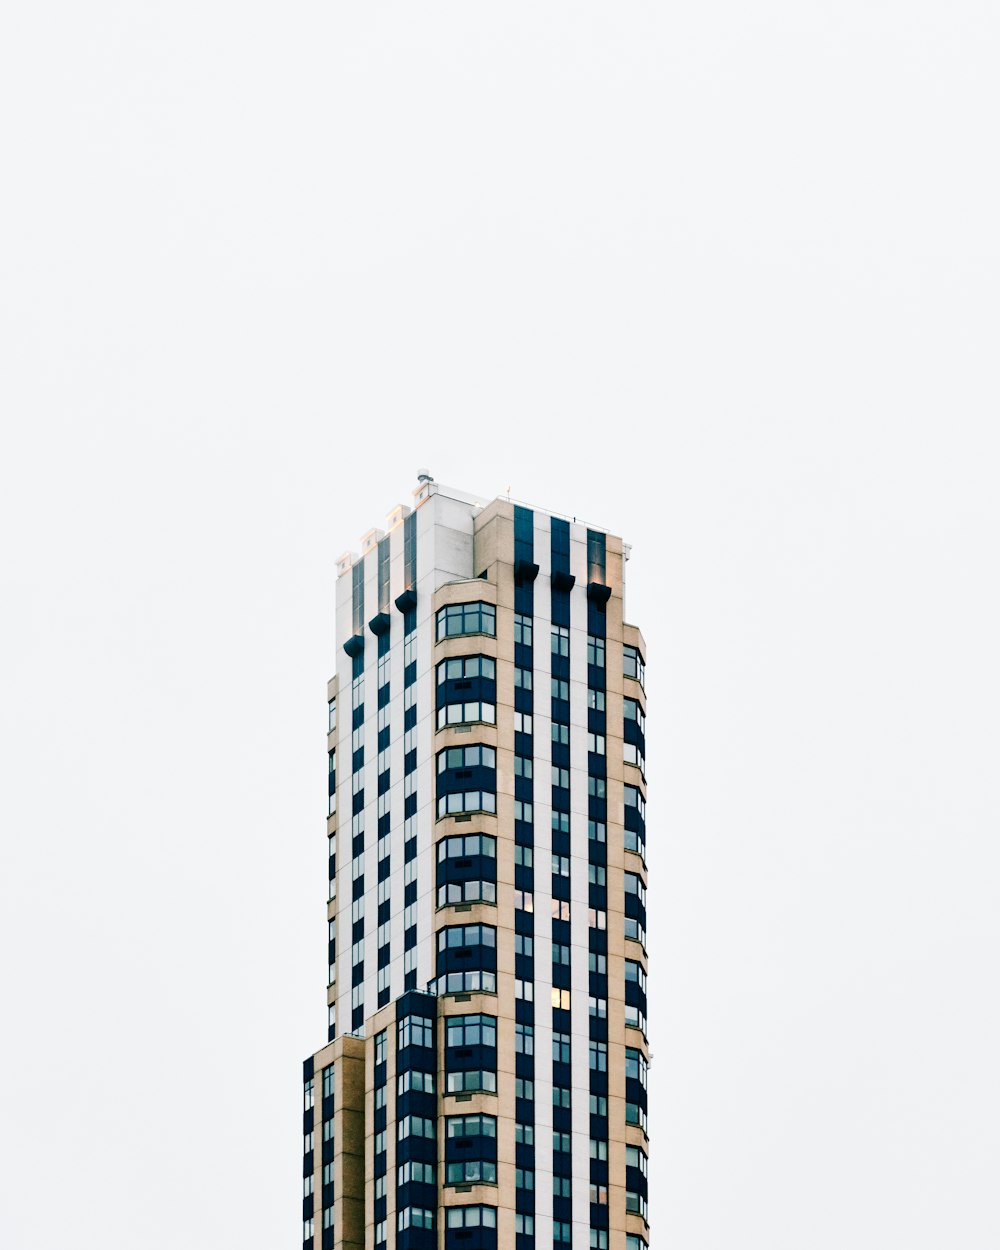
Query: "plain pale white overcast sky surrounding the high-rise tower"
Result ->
[[0, 0, 1000, 1250]]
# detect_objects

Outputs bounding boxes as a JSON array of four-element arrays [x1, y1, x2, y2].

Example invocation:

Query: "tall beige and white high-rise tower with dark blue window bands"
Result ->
[[303, 475, 649, 1250]]
